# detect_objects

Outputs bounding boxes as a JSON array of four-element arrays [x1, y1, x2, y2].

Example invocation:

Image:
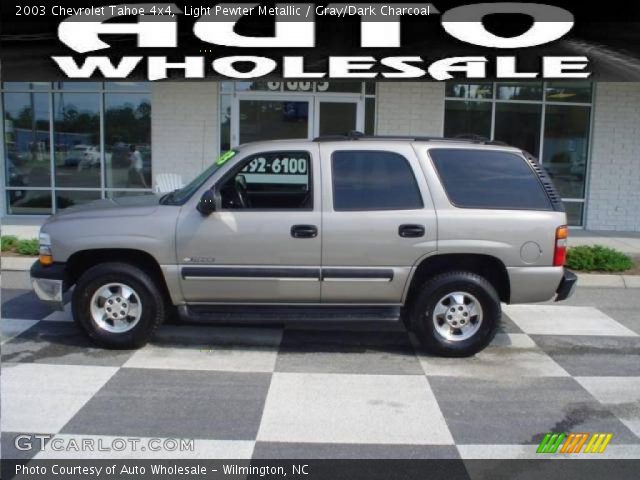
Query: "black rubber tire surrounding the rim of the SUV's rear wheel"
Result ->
[[408, 271, 502, 357]]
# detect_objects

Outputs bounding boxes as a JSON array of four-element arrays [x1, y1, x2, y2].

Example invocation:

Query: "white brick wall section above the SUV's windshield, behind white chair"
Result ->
[[151, 82, 220, 185]]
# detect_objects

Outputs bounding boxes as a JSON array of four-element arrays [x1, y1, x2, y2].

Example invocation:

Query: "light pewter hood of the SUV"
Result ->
[[47, 193, 160, 223]]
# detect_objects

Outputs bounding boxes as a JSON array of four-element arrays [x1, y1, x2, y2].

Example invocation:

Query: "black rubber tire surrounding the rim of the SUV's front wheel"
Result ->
[[71, 262, 166, 349]]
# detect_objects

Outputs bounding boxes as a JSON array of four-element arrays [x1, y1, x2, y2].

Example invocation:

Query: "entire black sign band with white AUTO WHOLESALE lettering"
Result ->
[[2, 2, 640, 81]]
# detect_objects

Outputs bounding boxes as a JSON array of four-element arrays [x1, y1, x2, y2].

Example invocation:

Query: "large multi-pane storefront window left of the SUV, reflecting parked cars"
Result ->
[[1, 82, 151, 215]]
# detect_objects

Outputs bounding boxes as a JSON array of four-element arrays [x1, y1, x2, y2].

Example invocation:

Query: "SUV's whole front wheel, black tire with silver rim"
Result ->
[[72, 262, 165, 348]]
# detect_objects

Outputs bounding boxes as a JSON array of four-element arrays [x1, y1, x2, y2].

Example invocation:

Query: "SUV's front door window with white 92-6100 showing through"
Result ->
[[220, 151, 313, 210]]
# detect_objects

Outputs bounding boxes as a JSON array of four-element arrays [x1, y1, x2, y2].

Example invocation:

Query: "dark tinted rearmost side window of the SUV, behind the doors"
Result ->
[[429, 148, 551, 210]]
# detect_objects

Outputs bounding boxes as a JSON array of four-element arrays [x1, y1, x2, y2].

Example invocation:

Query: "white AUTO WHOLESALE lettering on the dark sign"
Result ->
[[47, 2, 590, 80]]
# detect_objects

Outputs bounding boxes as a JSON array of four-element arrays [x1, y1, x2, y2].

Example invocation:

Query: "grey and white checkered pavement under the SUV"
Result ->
[[0, 291, 640, 459]]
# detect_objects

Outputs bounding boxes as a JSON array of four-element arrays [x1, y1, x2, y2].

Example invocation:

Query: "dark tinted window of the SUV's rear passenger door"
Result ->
[[332, 151, 422, 210]]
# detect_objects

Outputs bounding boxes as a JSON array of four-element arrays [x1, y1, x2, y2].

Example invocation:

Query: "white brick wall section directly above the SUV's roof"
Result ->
[[376, 82, 445, 136]]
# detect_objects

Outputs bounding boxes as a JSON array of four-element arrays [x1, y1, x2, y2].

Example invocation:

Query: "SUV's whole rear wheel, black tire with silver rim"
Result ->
[[409, 272, 501, 357]]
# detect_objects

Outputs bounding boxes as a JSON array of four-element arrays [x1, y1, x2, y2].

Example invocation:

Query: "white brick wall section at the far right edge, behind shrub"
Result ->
[[586, 82, 640, 232]]
